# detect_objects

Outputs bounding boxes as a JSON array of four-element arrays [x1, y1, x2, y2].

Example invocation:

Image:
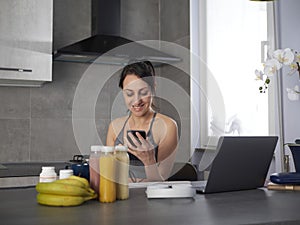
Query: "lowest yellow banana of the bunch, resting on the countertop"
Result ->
[[36, 193, 95, 206]]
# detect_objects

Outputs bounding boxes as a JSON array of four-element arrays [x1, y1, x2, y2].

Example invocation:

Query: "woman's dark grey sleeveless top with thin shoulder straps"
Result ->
[[115, 112, 158, 178]]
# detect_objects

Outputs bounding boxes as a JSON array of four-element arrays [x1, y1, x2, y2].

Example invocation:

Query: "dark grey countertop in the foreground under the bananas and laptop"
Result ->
[[0, 188, 300, 225]]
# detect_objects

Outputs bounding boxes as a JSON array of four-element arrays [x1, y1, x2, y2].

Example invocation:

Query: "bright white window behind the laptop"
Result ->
[[190, 0, 275, 147]]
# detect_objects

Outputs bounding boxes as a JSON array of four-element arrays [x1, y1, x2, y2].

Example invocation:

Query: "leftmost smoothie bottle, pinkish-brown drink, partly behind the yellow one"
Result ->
[[89, 145, 102, 196]]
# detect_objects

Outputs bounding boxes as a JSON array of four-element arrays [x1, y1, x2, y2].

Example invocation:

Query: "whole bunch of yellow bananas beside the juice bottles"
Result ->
[[36, 175, 97, 206]]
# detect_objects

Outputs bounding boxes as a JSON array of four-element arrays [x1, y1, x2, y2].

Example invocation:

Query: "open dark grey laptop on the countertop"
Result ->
[[195, 136, 278, 193]]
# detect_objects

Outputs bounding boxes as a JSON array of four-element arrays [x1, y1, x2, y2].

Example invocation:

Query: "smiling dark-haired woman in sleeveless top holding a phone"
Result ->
[[106, 61, 178, 181]]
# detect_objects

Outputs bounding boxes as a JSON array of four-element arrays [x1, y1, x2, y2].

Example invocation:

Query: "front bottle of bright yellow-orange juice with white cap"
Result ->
[[99, 146, 116, 202]]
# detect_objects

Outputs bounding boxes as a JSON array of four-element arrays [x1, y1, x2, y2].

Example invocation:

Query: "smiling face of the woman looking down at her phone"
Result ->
[[123, 74, 152, 116]]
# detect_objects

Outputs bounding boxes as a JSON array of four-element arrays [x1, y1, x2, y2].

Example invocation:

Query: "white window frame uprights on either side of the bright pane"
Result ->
[[190, 0, 283, 171]]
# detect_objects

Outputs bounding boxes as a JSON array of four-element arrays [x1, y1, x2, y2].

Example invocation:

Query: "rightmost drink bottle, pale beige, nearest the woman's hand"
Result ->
[[115, 145, 129, 200]]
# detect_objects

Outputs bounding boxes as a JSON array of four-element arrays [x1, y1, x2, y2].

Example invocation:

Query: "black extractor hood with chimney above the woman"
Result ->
[[54, 0, 180, 65]]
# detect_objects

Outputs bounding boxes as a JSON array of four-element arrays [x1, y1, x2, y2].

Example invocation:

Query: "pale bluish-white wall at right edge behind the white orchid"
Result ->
[[275, 0, 300, 169]]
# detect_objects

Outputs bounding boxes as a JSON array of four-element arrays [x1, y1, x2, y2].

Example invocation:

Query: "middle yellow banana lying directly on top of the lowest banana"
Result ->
[[35, 182, 94, 197]]
